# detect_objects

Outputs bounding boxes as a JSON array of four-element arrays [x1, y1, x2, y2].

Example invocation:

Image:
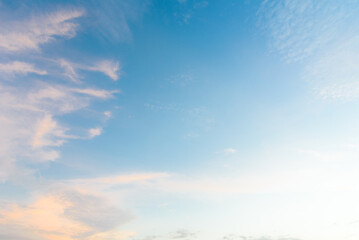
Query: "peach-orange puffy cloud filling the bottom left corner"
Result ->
[[0, 191, 133, 240]]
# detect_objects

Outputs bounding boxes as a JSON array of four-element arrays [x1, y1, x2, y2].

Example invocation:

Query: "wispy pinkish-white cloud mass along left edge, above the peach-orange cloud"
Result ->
[[0, 9, 119, 181]]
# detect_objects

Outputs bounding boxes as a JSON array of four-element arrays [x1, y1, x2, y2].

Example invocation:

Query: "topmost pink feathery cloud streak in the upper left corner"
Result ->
[[0, 9, 84, 52]]
